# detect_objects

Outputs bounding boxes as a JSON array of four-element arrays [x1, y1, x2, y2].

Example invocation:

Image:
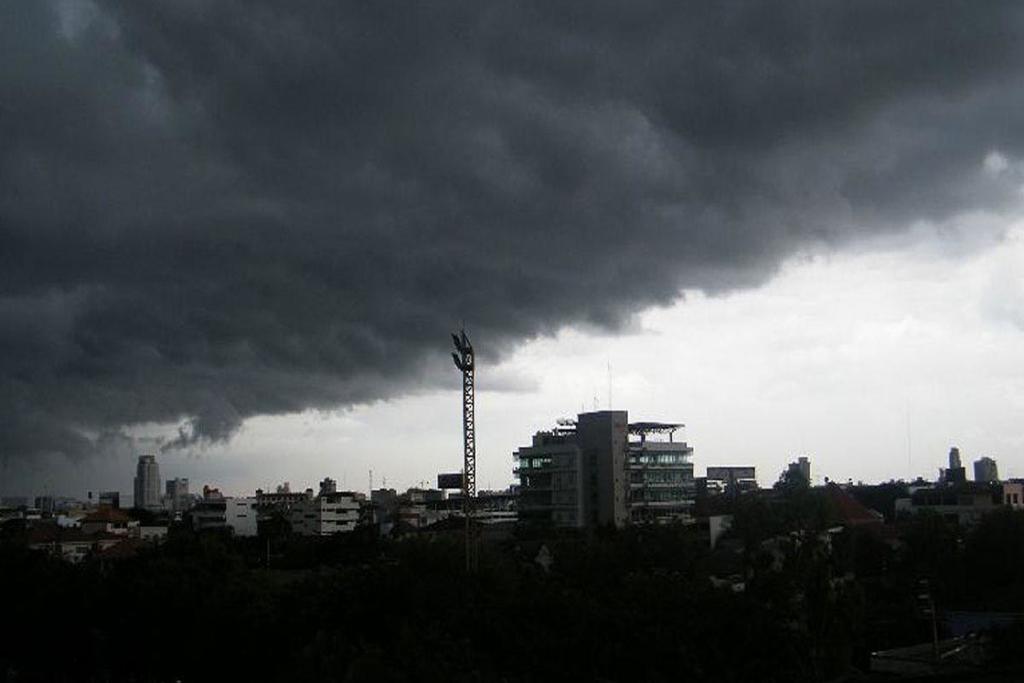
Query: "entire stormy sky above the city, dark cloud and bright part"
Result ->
[[0, 0, 1024, 495]]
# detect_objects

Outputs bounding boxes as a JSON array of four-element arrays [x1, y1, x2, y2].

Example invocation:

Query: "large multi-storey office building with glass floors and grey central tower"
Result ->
[[513, 411, 695, 527]]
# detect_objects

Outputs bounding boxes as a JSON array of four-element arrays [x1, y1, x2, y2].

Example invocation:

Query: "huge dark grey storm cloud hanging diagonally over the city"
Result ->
[[0, 0, 1024, 456]]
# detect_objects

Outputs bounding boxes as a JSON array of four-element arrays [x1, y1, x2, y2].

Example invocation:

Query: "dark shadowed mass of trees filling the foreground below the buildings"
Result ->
[[0, 501, 1024, 682]]
